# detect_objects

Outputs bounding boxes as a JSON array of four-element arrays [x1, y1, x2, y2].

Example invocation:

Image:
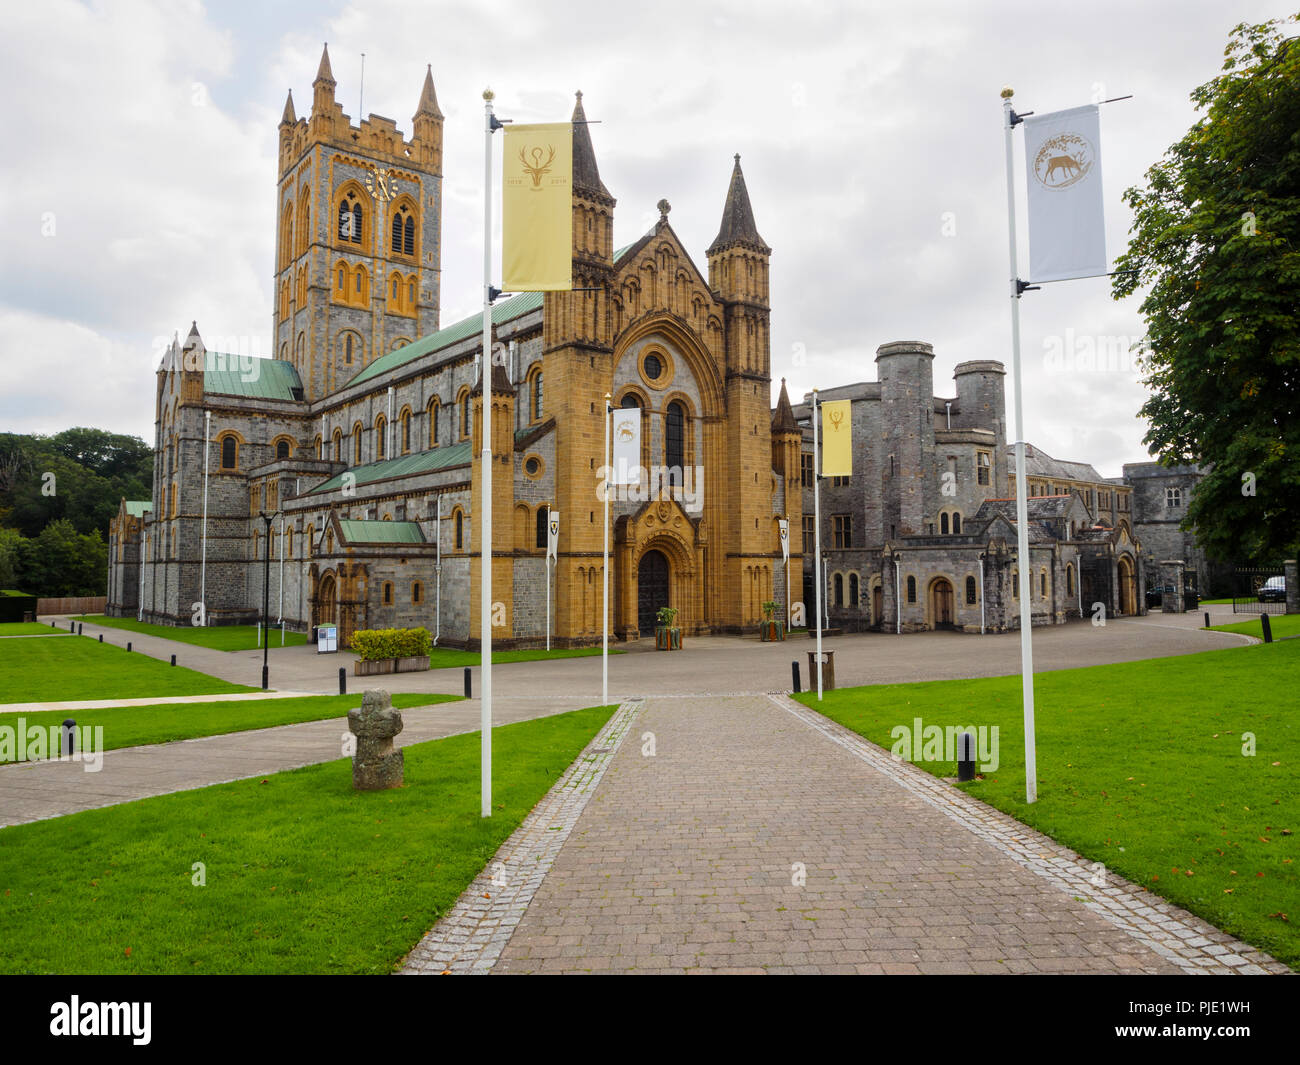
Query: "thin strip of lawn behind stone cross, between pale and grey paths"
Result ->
[[0, 692, 463, 763]]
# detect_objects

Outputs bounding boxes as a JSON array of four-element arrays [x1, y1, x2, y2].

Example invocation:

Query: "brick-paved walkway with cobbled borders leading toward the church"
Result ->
[[406, 696, 1287, 974]]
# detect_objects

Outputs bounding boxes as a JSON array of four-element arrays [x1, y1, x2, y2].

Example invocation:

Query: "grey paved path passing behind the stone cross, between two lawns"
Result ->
[[0, 700, 569, 827]]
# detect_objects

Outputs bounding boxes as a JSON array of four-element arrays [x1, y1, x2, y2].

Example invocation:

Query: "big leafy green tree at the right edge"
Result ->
[[1112, 16, 1300, 560]]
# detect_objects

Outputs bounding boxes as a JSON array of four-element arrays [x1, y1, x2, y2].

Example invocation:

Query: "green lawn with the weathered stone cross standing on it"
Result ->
[[0, 706, 615, 974]]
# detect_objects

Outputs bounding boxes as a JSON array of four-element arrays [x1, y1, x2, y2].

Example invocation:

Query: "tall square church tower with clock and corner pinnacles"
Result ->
[[272, 48, 442, 401]]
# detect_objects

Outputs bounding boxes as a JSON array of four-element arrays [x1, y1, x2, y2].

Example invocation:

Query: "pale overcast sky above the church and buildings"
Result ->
[[0, 0, 1287, 476]]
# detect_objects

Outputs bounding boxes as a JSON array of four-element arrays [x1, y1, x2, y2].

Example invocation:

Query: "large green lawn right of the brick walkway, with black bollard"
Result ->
[[796, 641, 1300, 967]]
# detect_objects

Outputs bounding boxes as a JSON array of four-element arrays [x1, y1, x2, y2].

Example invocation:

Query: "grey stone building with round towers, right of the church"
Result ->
[[792, 341, 1145, 632]]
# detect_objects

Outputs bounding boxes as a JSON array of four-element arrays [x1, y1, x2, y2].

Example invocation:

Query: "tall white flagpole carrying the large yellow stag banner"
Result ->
[[476, 88, 494, 817]]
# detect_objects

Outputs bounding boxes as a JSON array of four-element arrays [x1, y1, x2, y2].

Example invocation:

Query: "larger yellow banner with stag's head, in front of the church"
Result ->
[[501, 122, 573, 293]]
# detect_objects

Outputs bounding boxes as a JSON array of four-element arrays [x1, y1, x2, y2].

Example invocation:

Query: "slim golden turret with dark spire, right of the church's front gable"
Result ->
[[706, 155, 772, 616]]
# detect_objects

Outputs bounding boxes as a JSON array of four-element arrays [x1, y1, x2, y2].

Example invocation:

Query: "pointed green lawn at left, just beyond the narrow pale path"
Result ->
[[0, 636, 260, 703]]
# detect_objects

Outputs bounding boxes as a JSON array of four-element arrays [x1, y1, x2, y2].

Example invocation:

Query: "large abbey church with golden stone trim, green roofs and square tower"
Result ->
[[108, 51, 803, 646]]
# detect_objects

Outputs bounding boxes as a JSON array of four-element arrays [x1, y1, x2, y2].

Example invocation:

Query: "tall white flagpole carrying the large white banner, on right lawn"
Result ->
[[1002, 88, 1039, 802]]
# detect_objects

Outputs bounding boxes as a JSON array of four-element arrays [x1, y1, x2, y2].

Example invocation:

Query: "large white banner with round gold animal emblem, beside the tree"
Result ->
[[1024, 104, 1108, 282]]
